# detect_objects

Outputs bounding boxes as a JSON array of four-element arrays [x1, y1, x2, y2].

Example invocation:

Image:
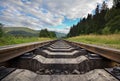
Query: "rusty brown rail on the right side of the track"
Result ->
[[65, 40, 120, 63]]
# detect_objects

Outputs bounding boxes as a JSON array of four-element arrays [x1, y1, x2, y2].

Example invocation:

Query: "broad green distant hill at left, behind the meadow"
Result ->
[[3, 27, 39, 36]]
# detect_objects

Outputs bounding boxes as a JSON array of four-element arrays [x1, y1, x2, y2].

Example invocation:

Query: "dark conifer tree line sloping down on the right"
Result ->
[[67, 0, 120, 37]]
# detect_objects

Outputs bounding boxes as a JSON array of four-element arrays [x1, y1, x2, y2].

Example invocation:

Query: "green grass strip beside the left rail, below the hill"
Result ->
[[0, 36, 53, 46]]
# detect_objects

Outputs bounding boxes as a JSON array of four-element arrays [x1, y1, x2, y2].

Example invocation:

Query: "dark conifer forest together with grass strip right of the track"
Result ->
[[67, 0, 120, 49]]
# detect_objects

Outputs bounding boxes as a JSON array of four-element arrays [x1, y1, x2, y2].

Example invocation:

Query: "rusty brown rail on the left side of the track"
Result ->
[[0, 41, 53, 63]]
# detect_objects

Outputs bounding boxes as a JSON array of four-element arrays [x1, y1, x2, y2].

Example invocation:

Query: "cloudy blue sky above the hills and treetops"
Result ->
[[0, 0, 112, 33]]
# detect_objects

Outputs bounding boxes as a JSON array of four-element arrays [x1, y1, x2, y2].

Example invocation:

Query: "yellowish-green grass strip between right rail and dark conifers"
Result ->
[[67, 34, 120, 49]]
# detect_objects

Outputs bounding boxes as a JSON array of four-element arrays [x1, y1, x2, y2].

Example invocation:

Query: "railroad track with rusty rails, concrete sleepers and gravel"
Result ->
[[0, 40, 120, 81]]
